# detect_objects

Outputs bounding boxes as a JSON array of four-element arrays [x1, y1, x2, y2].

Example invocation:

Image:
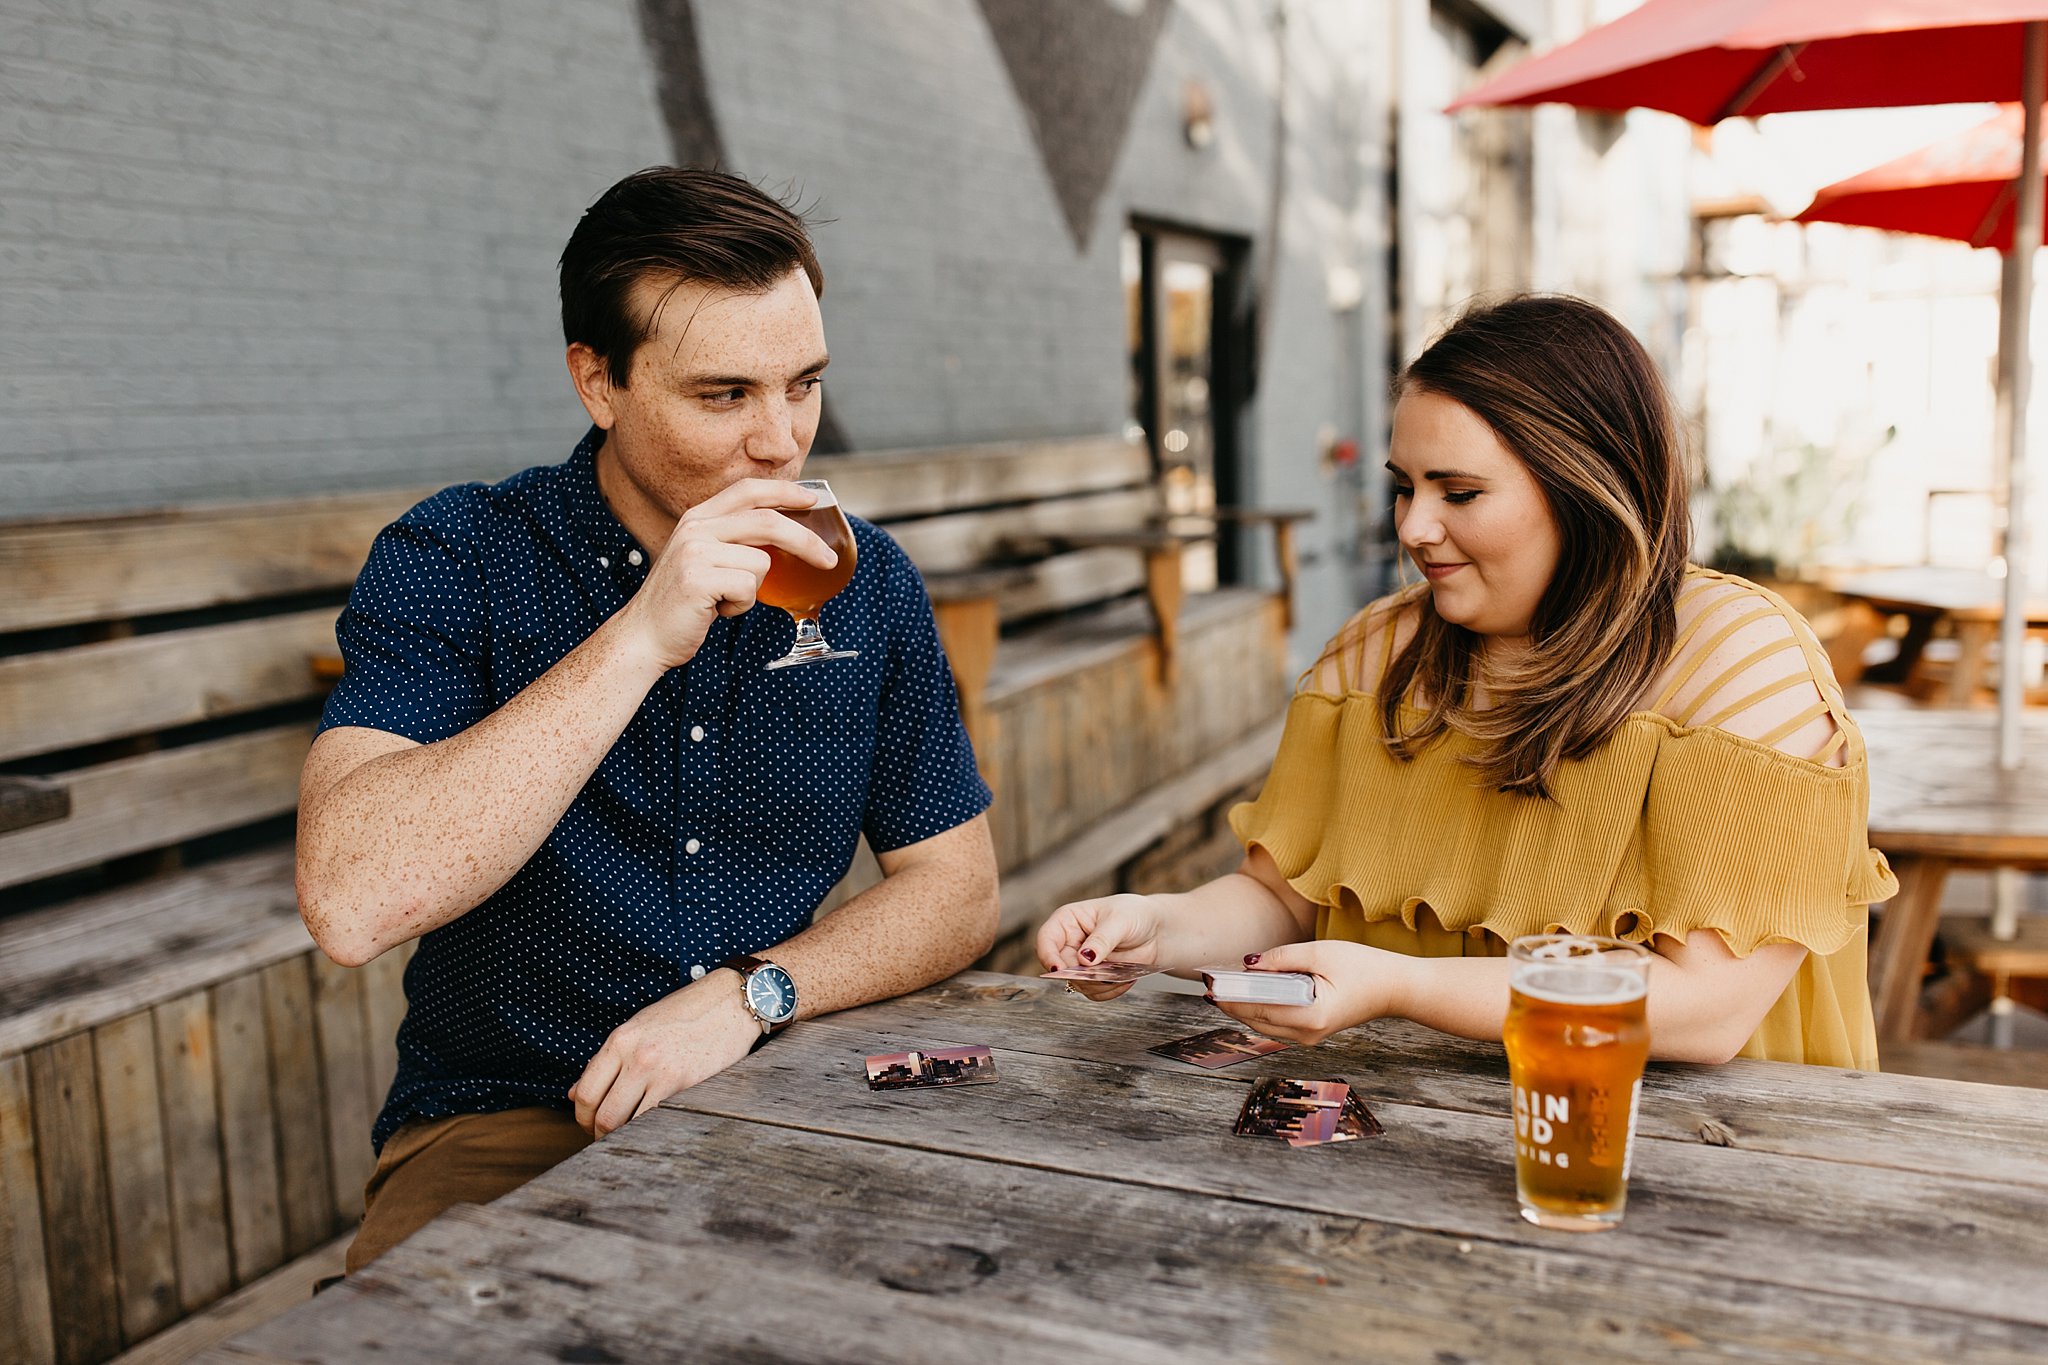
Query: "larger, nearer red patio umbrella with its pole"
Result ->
[[1452, 0, 2048, 767]]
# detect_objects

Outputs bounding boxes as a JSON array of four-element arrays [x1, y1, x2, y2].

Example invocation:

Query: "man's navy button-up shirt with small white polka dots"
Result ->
[[319, 430, 989, 1150]]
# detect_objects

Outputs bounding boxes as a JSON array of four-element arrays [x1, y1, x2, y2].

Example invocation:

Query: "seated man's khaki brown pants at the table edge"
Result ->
[[346, 1109, 590, 1275]]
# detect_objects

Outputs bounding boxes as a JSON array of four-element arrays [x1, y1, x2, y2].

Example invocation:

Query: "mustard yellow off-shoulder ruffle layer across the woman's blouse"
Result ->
[[1231, 692, 1896, 956]]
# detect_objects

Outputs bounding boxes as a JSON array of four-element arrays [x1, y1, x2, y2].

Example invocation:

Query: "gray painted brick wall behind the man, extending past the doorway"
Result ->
[[0, 0, 1386, 641]]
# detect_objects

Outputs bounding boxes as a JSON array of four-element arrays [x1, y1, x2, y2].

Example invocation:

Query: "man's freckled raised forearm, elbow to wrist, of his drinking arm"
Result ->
[[299, 616, 662, 962]]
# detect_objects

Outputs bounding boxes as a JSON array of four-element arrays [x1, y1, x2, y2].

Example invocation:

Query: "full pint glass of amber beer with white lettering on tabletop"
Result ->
[[1501, 933, 1653, 1232]]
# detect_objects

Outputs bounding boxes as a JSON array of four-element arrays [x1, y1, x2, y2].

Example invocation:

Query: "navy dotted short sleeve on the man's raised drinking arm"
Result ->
[[319, 487, 492, 745]]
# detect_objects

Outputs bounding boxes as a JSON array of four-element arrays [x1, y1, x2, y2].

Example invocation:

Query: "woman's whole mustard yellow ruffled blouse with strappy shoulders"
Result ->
[[1231, 569, 1898, 1070]]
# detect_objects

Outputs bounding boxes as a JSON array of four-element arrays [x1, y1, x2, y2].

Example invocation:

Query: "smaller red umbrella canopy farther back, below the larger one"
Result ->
[[1794, 104, 2025, 252]]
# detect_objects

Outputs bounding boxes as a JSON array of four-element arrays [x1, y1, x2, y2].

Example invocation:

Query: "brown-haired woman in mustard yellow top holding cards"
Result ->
[[1038, 295, 1896, 1068]]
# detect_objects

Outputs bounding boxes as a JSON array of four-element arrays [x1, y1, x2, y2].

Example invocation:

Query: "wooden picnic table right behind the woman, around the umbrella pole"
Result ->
[[1855, 708, 2048, 1050]]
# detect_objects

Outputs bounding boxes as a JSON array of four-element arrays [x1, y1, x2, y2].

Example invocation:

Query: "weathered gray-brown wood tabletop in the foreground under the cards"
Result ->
[[207, 974, 2048, 1365]]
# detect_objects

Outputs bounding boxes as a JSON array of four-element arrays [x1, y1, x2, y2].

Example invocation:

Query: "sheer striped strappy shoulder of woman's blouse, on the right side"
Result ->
[[1651, 569, 1853, 767]]
